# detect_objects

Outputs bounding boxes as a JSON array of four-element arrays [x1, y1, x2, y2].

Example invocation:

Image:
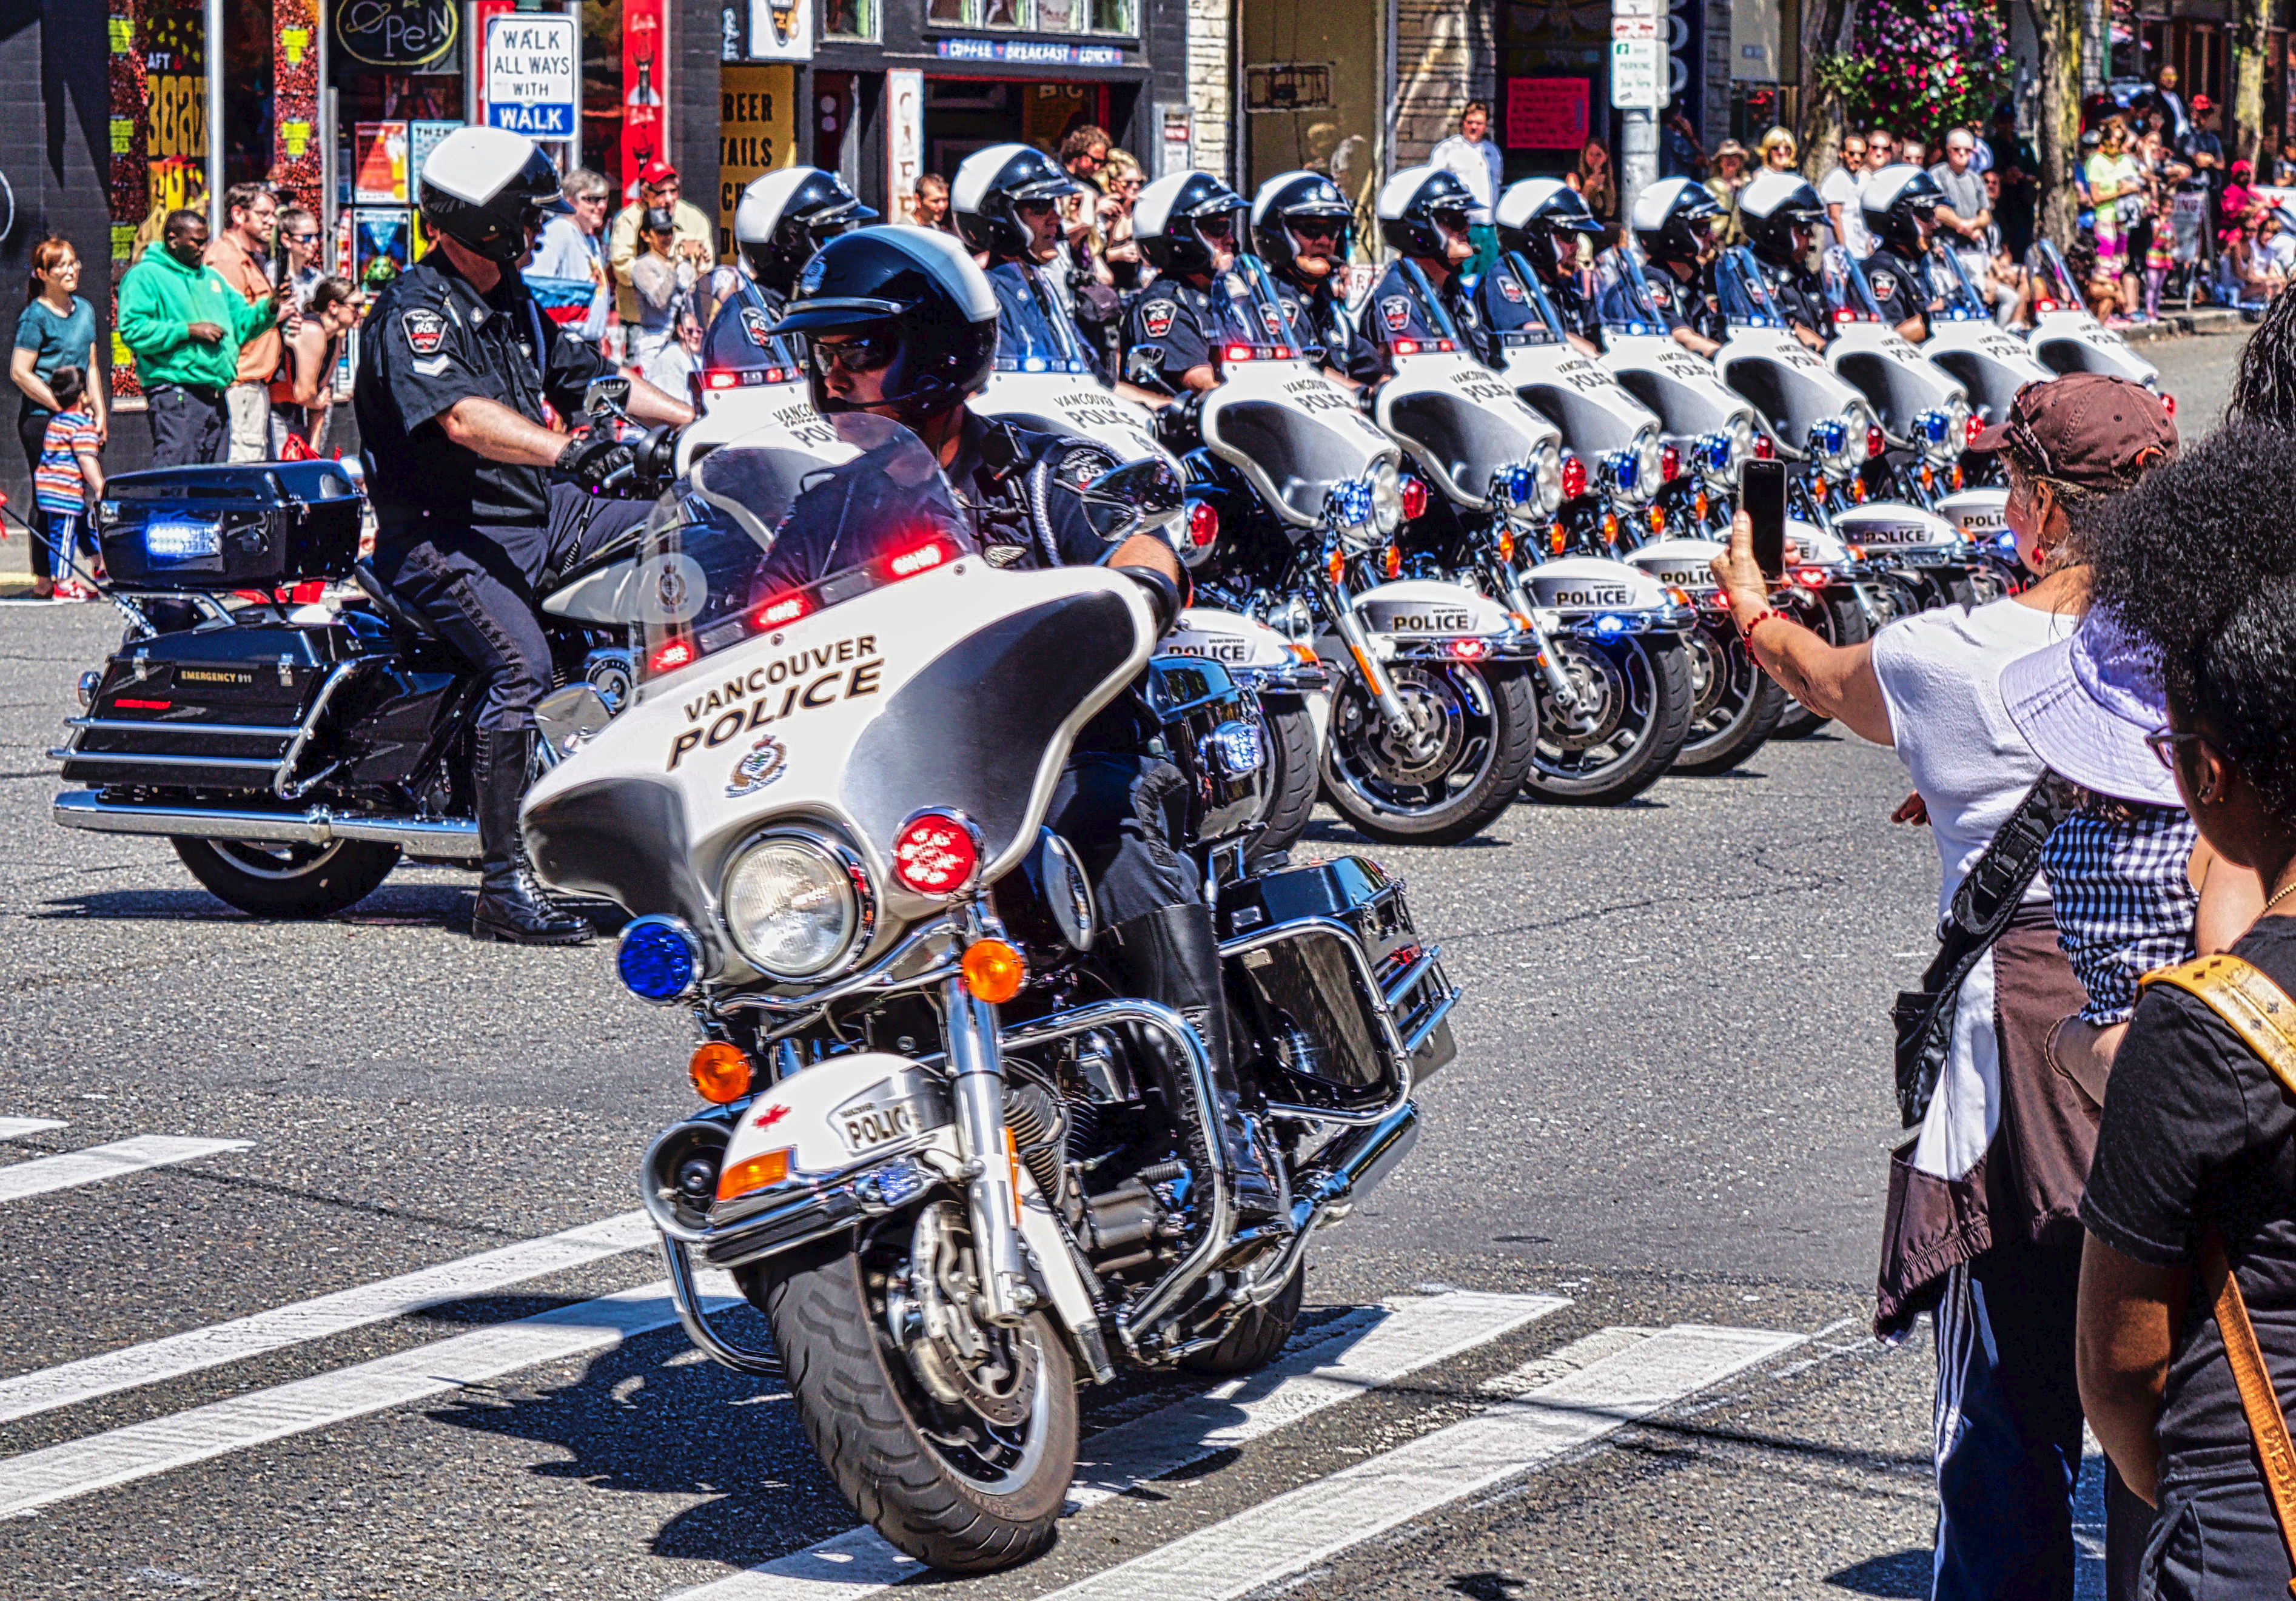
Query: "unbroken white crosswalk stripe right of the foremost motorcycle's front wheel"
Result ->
[[1042, 1323, 1802, 1601]]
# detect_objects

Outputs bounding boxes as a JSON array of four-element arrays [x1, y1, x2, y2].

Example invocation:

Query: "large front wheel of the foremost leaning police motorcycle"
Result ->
[[737, 1199, 1077, 1574]]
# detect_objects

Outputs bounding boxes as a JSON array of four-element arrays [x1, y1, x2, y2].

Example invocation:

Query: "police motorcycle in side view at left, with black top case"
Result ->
[[50, 379, 675, 916]]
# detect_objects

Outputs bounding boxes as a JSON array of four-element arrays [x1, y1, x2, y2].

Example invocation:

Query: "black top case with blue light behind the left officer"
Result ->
[[96, 462, 363, 590]]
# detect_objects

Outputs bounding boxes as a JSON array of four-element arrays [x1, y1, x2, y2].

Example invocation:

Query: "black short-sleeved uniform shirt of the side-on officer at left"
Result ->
[[351, 250, 613, 577]]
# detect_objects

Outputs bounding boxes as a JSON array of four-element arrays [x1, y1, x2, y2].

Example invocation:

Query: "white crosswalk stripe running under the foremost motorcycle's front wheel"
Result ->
[[677, 1291, 1571, 1601]]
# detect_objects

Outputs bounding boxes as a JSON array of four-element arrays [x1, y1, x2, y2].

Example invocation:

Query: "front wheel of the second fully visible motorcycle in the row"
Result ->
[[1527, 634, 1690, 806]]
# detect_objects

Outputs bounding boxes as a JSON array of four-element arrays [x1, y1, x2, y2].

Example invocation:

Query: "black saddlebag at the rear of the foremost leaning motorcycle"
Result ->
[[1219, 857, 1458, 1112]]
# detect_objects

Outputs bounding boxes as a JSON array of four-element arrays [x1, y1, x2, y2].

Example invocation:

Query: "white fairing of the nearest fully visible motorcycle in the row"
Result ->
[[1197, 361, 1395, 528]]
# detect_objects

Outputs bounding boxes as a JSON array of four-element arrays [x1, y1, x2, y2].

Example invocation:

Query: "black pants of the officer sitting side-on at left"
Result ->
[[374, 485, 654, 730]]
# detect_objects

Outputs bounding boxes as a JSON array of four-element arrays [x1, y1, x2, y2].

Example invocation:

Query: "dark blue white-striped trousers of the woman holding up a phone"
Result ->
[[1933, 1245, 2080, 1601]]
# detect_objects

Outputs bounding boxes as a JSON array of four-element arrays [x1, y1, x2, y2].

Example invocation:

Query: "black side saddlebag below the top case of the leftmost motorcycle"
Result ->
[[58, 622, 365, 793]]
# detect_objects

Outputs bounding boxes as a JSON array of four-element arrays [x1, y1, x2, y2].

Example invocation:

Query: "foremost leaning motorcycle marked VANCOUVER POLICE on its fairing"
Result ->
[[537, 414, 1458, 1574]]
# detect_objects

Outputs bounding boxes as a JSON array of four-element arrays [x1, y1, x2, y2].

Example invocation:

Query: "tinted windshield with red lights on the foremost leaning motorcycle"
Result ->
[[629, 411, 973, 677]]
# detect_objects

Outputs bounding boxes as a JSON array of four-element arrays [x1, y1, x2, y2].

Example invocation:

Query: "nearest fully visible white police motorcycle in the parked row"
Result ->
[[1127, 172, 1539, 845]]
